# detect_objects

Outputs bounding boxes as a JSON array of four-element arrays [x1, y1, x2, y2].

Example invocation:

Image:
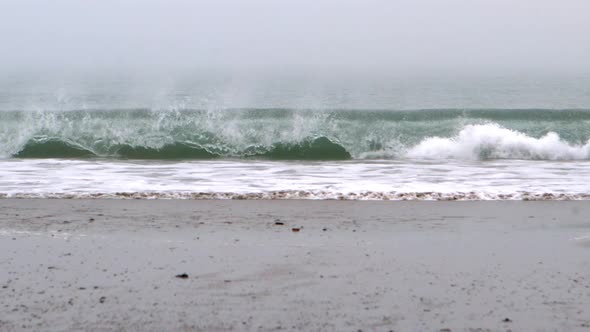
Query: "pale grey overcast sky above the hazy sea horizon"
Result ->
[[0, 0, 590, 69]]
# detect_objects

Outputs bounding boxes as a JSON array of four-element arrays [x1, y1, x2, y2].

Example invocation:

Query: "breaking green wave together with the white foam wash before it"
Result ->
[[0, 109, 590, 200]]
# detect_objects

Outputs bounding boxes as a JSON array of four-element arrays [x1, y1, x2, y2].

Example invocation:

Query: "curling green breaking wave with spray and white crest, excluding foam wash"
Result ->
[[0, 109, 590, 160]]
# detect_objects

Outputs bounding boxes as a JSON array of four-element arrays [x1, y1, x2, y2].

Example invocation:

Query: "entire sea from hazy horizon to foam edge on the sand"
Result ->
[[0, 71, 590, 200]]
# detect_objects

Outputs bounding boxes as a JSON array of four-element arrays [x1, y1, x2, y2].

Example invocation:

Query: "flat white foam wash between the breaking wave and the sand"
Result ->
[[0, 159, 590, 200]]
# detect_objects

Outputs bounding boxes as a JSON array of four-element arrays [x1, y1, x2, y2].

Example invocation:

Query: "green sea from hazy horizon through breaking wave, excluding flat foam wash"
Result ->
[[0, 71, 590, 160]]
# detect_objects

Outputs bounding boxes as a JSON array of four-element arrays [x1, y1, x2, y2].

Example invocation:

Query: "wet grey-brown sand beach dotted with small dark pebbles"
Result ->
[[0, 199, 590, 331]]
